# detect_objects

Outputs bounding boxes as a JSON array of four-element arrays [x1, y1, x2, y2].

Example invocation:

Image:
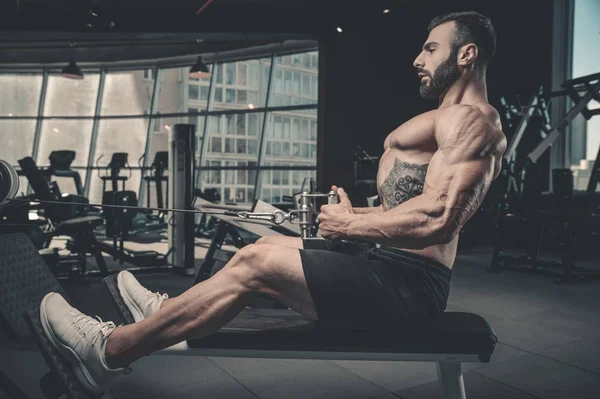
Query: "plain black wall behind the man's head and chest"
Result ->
[[318, 0, 552, 194]]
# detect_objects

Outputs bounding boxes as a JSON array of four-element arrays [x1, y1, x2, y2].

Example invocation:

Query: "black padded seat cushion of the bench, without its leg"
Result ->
[[187, 309, 497, 362]]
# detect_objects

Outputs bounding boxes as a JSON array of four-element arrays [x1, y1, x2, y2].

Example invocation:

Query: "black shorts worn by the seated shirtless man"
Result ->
[[300, 240, 452, 328]]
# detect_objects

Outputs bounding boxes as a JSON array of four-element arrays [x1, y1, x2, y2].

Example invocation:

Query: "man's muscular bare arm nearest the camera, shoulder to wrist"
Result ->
[[336, 105, 506, 249]]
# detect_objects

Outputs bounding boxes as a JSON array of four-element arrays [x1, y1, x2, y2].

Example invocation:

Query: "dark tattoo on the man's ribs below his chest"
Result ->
[[380, 158, 429, 210]]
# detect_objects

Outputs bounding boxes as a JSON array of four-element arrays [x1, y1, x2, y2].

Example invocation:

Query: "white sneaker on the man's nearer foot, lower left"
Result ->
[[40, 292, 131, 393]]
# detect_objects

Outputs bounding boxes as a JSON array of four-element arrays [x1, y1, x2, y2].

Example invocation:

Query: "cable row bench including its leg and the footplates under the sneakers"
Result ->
[[26, 275, 497, 399]]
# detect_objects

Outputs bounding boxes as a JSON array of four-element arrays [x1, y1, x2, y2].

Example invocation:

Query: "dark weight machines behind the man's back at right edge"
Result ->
[[490, 73, 600, 283]]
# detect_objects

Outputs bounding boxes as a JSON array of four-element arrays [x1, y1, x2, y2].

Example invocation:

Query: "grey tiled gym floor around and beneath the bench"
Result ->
[[0, 242, 600, 399]]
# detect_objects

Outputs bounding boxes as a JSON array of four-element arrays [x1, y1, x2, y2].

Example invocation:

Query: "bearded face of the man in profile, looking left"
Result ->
[[413, 22, 460, 99]]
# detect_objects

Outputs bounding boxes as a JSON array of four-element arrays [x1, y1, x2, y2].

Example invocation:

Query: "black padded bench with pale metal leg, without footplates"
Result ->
[[180, 309, 496, 399]]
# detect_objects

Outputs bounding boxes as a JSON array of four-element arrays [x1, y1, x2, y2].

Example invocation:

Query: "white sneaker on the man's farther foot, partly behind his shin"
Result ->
[[117, 270, 169, 323]]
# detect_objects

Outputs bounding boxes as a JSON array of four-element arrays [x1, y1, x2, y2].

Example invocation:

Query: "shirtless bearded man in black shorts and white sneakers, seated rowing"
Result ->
[[40, 12, 506, 391]]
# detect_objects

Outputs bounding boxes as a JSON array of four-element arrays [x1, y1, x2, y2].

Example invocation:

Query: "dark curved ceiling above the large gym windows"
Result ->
[[0, 0, 434, 68]]
